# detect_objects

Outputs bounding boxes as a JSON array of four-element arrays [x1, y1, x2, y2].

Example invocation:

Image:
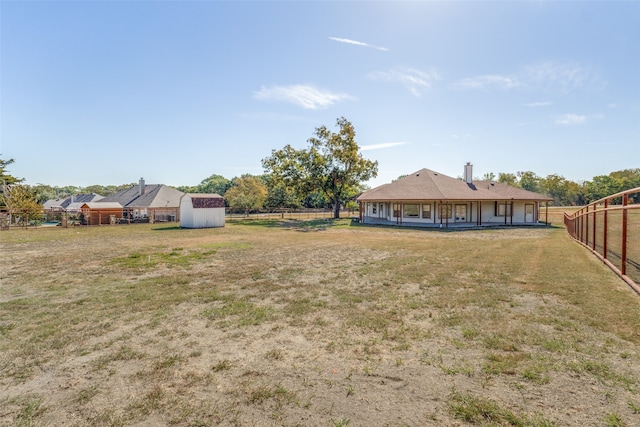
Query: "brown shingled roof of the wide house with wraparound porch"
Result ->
[[357, 169, 553, 202]]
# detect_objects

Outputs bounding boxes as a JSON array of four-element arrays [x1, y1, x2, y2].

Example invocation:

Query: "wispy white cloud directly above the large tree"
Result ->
[[254, 85, 353, 110]]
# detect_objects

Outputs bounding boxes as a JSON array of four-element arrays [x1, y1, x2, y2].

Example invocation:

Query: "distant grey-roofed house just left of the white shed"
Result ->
[[98, 178, 184, 222]]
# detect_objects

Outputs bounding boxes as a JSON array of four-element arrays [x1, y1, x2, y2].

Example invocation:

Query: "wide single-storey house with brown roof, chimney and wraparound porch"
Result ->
[[357, 163, 553, 227]]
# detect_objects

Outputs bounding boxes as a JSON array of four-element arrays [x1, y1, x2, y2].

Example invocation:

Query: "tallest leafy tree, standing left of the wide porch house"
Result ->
[[262, 117, 378, 218]]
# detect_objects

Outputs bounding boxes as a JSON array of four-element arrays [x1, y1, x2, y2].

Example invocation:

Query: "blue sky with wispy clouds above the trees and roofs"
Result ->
[[0, 0, 640, 186]]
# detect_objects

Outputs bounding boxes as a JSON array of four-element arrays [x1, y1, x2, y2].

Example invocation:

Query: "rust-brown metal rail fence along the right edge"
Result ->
[[564, 187, 640, 295]]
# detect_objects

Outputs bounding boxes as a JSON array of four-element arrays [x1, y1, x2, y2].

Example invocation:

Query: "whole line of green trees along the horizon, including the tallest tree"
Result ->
[[0, 117, 640, 217]]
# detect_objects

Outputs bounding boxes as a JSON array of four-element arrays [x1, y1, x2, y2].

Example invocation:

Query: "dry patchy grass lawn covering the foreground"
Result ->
[[0, 220, 640, 426]]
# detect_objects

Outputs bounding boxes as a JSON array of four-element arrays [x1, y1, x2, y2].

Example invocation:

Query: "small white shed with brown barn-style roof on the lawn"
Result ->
[[180, 193, 225, 228]]
